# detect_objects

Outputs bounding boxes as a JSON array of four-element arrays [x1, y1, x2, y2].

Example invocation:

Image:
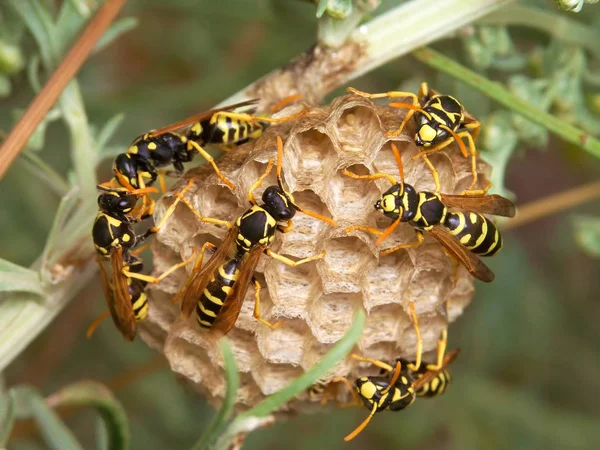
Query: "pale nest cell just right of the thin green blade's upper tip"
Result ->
[[359, 304, 409, 350]]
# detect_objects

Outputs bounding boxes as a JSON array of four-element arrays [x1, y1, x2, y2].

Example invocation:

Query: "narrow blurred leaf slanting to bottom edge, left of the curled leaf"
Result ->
[[13, 387, 83, 450]]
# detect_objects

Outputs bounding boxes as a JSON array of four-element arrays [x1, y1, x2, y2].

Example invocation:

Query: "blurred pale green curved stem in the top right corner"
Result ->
[[478, 5, 600, 58]]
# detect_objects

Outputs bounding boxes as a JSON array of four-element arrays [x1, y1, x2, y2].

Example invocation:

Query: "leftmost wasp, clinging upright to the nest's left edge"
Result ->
[[87, 183, 195, 341]]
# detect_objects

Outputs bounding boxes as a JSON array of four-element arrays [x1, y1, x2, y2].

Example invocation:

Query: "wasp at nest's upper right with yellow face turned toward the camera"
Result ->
[[348, 82, 491, 194]]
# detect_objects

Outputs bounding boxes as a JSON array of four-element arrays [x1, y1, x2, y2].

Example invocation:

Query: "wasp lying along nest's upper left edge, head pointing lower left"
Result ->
[[106, 97, 304, 197]]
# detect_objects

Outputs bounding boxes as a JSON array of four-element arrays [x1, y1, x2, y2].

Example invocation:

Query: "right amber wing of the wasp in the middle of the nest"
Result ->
[[211, 245, 265, 335]]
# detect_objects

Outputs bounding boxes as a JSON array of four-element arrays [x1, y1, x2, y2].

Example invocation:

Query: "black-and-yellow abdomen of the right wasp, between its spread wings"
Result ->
[[444, 212, 502, 256]]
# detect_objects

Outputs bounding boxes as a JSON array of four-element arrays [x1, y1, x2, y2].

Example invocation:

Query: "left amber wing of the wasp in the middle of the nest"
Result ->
[[181, 226, 238, 318]]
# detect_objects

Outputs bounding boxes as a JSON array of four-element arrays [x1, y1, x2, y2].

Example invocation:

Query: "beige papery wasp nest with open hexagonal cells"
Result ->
[[141, 95, 489, 409]]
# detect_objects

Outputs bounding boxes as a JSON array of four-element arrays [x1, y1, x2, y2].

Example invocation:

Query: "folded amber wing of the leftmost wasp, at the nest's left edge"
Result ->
[[106, 247, 135, 341]]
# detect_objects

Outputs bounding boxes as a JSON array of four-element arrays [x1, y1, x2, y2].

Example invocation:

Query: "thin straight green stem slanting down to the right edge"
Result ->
[[413, 47, 600, 158]]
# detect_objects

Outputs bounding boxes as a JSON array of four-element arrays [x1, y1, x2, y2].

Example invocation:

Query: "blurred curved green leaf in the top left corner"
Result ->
[[7, 0, 59, 70]]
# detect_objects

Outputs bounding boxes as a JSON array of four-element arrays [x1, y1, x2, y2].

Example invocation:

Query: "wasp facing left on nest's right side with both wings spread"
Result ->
[[344, 144, 515, 282]]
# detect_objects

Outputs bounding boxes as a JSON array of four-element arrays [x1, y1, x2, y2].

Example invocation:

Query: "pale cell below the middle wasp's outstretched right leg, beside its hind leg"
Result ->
[[265, 261, 323, 317]]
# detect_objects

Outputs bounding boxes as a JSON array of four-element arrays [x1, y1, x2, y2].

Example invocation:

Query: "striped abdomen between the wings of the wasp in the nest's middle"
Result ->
[[196, 258, 240, 328]]
